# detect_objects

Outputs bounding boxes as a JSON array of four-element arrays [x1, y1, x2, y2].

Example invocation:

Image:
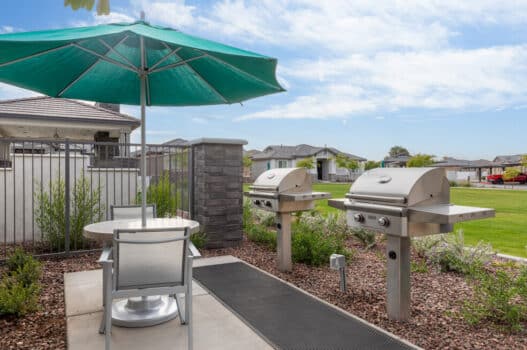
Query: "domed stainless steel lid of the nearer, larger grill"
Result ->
[[346, 168, 450, 206]]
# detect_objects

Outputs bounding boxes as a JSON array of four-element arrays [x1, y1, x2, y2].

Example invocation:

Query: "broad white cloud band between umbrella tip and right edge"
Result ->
[[238, 46, 527, 120]]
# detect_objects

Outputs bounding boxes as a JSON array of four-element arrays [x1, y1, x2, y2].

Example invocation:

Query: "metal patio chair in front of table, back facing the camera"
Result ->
[[99, 227, 201, 350]]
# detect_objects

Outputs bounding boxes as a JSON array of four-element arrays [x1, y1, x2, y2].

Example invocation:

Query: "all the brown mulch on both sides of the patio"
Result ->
[[0, 240, 527, 350]]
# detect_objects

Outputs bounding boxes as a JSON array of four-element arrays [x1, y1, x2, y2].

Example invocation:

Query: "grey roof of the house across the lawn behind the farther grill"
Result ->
[[252, 144, 366, 161]]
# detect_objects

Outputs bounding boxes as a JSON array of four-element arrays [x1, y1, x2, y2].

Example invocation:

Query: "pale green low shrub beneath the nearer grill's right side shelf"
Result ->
[[414, 230, 494, 275]]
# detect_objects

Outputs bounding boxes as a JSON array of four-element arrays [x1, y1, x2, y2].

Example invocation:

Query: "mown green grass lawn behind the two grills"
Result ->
[[244, 184, 527, 257]]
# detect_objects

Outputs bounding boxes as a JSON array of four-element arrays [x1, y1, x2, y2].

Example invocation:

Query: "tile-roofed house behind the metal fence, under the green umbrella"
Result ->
[[0, 96, 141, 167]]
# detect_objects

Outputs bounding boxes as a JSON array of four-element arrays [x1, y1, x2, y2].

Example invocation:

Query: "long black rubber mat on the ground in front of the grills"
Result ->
[[193, 262, 412, 350]]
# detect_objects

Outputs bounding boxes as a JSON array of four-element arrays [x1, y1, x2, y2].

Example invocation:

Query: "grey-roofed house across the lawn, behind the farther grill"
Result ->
[[251, 144, 366, 181]]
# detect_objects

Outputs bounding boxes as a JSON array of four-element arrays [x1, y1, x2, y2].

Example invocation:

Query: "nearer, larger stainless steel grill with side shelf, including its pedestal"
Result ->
[[329, 168, 495, 320]]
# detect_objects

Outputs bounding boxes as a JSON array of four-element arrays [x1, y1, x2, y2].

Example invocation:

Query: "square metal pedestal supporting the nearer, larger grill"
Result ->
[[386, 235, 410, 321]]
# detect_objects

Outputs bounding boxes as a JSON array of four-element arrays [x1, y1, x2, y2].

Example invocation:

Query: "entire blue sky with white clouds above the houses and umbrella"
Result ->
[[0, 0, 527, 159]]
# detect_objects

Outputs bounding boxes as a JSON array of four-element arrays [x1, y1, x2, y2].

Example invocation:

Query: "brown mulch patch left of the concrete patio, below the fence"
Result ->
[[0, 252, 100, 350]]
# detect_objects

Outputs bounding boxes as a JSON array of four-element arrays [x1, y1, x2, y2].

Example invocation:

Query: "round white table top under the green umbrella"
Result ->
[[84, 217, 199, 241]]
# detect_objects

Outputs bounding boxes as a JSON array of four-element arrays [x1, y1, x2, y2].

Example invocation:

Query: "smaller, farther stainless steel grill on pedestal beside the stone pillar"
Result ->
[[245, 168, 331, 271]]
